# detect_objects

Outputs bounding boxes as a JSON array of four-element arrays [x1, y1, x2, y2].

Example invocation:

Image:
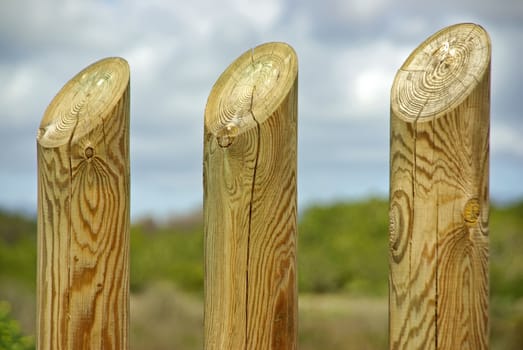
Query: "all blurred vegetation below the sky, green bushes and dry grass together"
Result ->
[[0, 199, 523, 350]]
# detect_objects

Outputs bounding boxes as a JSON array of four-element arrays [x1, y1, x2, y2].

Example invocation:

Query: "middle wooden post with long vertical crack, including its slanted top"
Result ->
[[204, 43, 298, 349]]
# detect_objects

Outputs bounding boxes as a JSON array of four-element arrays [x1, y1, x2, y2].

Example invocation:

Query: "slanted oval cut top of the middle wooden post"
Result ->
[[205, 42, 298, 147]]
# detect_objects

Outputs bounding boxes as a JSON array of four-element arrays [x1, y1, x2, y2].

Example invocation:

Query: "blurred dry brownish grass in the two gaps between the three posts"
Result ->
[[131, 283, 387, 350]]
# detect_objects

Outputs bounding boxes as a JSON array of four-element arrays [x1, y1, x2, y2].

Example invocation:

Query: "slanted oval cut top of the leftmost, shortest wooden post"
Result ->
[[37, 57, 130, 148]]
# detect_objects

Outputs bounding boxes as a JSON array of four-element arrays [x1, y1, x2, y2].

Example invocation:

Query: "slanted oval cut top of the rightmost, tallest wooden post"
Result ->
[[391, 23, 491, 122]]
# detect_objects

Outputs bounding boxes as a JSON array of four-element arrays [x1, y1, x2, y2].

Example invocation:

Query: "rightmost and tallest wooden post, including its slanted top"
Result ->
[[389, 24, 491, 350]]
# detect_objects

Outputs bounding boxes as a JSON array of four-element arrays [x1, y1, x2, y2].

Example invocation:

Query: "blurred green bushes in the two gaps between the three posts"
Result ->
[[127, 199, 388, 296]]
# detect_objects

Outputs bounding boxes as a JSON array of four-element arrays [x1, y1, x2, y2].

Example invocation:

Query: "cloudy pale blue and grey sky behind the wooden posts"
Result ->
[[0, 0, 523, 218]]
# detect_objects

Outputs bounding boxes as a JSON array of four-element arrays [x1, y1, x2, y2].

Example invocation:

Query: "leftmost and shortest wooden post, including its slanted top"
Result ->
[[37, 58, 129, 350]]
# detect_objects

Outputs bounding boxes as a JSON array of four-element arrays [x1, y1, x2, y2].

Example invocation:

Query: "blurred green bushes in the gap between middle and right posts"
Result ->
[[298, 199, 388, 296]]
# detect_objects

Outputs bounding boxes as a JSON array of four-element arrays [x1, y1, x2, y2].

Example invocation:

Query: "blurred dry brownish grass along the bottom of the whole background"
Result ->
[[0, 280, 523, 350]]
